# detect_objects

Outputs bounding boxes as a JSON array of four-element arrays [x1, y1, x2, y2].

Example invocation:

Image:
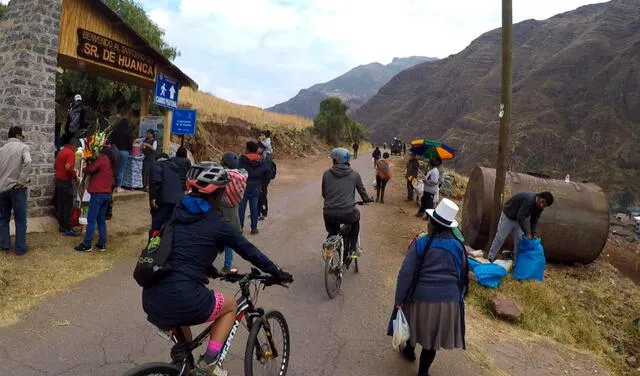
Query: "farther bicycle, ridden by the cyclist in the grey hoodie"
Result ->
[[322, 201, 366, 299]]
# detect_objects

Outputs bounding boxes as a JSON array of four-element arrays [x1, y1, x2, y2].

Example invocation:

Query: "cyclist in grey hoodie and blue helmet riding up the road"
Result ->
[[322, 148, 373, 258]]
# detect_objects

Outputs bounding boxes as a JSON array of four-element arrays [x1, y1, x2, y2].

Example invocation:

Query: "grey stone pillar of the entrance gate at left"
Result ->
[[0, 0, 61, 216]]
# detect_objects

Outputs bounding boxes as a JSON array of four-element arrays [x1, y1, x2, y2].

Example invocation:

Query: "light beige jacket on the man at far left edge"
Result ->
[[0, 138, 31, 192]]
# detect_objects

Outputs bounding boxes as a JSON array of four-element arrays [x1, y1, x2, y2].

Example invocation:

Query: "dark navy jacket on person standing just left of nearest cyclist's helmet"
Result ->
[[149, 160, 184, 205]]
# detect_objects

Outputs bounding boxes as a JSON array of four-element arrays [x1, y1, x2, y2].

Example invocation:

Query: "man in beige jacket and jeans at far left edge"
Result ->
[[0, 127, 31, 255]]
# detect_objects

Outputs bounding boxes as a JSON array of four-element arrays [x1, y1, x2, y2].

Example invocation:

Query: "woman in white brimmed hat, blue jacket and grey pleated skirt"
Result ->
[[388, 198, 469, 376]]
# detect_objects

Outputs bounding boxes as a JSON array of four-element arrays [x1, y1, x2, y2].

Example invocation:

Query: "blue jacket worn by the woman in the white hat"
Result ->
[[395, 233, 469, 305]]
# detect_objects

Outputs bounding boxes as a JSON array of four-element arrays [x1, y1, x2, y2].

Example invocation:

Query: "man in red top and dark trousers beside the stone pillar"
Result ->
[[53, 134, 80, 236]]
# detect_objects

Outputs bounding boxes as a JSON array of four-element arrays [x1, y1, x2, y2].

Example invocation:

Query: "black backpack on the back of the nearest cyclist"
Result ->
[[133, 218, 173, 288]]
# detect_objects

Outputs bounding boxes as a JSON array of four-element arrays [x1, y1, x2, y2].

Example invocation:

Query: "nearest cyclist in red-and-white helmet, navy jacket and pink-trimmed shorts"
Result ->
[[142, 162, 293, 376]]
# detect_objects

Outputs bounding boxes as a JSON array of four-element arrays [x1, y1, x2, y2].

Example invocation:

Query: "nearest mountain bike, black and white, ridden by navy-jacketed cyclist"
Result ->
[[123, 268, 291, 376]]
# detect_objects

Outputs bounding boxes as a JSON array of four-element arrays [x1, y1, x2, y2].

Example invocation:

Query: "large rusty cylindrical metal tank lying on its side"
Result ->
[[462, 167, 610, 264]]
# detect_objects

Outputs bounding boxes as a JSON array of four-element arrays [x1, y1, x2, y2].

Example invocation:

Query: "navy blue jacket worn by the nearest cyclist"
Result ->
[[142, 195, 276, 327]]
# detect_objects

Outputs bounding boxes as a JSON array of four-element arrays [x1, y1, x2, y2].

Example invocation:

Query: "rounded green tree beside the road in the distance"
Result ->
[[313, 98, 351, 145]]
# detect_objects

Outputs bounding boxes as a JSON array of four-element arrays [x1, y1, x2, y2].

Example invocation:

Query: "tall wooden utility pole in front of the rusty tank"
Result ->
[[489, 0, 513, 246]]
